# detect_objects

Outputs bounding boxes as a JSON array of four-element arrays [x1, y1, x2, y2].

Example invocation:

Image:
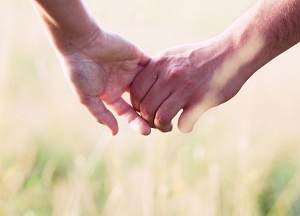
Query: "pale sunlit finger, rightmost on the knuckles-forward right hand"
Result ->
[[178, 99, 214, 133]]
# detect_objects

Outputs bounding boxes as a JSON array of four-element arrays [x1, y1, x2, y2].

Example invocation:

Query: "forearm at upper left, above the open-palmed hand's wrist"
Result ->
[[33, 0, 100, 53]]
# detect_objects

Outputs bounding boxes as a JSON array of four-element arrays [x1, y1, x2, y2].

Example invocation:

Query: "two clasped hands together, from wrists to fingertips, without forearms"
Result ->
[[61, 30, 246, 135]]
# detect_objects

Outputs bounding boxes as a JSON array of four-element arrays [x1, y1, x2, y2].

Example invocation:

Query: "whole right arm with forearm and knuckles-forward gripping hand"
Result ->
[[130, 0, 300, 132]]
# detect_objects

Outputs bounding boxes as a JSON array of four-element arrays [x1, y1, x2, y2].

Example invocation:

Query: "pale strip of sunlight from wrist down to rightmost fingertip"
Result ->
[[178, 37, 265, 133]]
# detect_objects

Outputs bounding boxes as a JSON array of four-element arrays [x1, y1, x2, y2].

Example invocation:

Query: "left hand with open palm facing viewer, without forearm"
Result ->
[[55, 28, 151, 135]]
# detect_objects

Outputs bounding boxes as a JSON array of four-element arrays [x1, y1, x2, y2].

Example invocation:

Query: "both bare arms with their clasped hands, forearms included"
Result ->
[[37, 0, 300, 135]]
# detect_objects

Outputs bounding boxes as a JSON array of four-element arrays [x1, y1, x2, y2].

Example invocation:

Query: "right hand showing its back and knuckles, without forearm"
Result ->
[[131, 37, 257, 132]]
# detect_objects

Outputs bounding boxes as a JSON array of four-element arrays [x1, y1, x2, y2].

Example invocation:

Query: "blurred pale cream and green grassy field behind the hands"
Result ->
[[0, 0, 300, 216]]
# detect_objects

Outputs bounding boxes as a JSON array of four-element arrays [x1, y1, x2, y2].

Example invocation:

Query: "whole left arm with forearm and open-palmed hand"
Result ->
[[33, 0, 151, 135]]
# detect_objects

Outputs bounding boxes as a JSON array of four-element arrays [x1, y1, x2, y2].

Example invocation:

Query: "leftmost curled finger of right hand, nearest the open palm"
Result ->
[[130, 63, 157, 111]]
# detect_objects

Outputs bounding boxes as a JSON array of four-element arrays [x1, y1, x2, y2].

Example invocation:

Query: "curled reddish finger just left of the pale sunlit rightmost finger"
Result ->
[[154, 95, 185, 132]]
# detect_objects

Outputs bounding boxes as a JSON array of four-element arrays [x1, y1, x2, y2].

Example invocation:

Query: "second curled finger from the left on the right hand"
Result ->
[[140, 80, 171, 127]]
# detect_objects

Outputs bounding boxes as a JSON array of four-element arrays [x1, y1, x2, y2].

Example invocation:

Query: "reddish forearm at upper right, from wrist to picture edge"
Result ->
[[218, 0, 300, 81]]
